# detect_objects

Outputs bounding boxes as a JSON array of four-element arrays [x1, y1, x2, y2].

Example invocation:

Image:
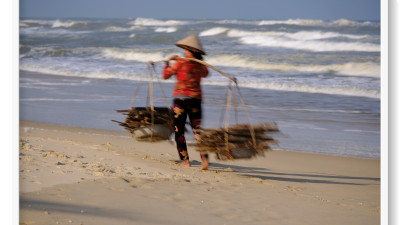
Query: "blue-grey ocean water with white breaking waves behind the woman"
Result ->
[[20, 18, 381, 158]]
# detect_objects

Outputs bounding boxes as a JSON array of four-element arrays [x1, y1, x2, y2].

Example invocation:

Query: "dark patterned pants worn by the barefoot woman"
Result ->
[[173, 98, 208, 160]]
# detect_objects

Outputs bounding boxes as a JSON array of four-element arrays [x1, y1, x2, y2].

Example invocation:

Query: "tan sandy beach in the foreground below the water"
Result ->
[[19, 121, 380, 225]]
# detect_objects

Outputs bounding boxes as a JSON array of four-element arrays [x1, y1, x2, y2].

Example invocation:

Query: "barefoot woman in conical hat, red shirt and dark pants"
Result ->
[[163, 35, 209, 170]]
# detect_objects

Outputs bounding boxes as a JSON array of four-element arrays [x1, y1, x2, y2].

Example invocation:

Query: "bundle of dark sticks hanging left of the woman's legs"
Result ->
[[111, 107, 173, 141]]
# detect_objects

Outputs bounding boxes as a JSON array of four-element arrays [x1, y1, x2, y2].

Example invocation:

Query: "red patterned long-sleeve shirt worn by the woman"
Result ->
[[163, 58, 208, 99]]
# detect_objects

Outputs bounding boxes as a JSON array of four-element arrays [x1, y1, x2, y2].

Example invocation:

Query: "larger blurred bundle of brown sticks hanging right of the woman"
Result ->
[[196, 122, 279, 160]]
